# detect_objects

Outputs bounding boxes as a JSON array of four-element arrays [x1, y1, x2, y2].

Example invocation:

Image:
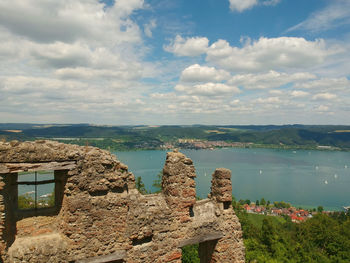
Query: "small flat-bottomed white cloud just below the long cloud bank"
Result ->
[[180, 64, 231, 82]]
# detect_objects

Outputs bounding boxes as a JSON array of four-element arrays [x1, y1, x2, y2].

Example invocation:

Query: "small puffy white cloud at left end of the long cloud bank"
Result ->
[[164, 35, 209, 57]]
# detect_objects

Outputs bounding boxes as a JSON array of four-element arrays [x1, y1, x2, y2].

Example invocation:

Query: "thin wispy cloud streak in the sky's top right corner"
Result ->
[[287, 0, 350, 32]]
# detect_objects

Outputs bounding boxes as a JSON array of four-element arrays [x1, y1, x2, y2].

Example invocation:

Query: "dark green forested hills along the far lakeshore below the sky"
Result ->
[[0, 123, 350, 150]]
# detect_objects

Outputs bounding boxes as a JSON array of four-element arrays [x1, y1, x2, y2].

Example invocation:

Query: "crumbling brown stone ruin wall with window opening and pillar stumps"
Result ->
[[0, 141, 244, 263]]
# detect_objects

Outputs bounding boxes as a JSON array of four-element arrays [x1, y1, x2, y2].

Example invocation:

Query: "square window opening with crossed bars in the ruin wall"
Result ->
[[17, 171, 55, 210]]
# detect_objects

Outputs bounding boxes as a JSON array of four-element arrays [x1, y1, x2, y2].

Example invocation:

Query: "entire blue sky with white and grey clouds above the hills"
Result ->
[[0, 0, 350, 125]]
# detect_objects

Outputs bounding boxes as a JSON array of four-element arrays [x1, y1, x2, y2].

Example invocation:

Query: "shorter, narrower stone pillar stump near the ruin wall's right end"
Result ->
[[210, 168, 232, 209]]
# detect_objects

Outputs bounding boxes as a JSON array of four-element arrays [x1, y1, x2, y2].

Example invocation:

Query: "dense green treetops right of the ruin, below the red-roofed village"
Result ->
[[238, 212, 350, 263]]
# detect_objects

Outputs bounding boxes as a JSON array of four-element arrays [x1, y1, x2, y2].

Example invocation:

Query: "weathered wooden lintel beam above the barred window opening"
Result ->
[[0, 161, 76, 174]]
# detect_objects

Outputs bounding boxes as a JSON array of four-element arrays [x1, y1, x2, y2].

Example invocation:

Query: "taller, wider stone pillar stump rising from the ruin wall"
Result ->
[[162, 151, 196, 222]]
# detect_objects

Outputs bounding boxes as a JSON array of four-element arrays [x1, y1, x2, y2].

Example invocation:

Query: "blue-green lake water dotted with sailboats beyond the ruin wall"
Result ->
[[115, 148, 350, 210]]
